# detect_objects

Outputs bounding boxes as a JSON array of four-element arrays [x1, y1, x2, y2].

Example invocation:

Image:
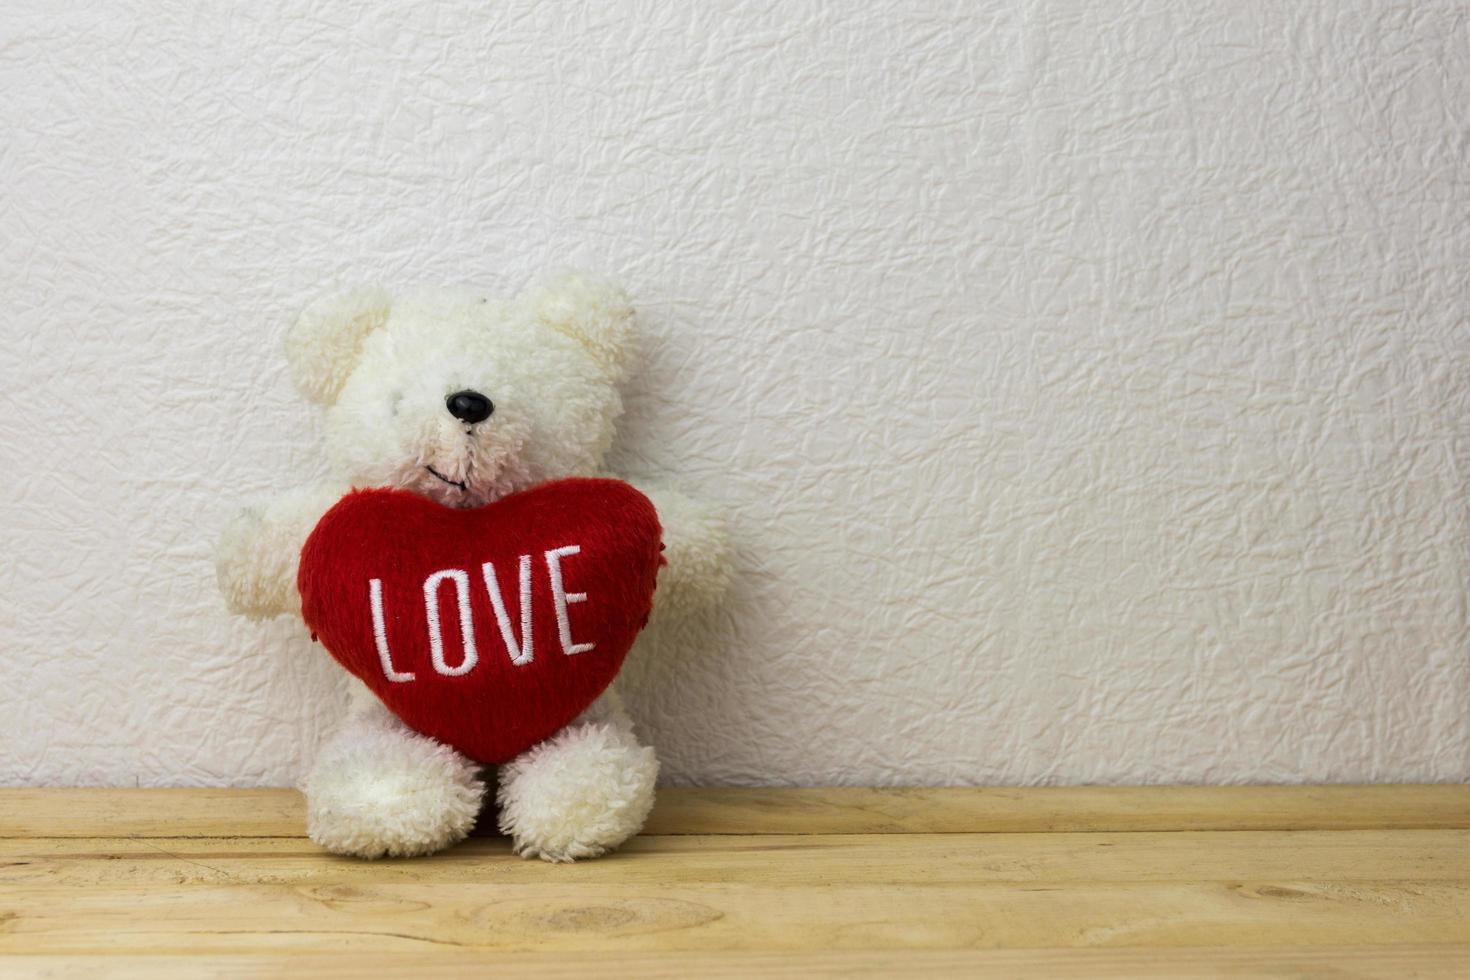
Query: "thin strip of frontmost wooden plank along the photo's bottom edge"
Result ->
[[0, 945, 1470, 980]]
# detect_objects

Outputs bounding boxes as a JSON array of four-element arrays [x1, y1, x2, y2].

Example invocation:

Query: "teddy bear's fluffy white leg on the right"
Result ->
[[498, 691, 659, 861]]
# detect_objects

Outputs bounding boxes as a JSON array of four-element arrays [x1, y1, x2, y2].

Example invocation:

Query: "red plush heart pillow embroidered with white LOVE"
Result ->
[[297, 479, 662, 763]]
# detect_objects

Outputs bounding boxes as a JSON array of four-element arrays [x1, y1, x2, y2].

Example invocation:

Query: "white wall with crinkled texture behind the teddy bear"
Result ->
[[0, 0, 1470, 785]]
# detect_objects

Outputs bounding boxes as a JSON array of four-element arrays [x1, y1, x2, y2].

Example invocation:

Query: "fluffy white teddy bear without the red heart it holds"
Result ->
[[216, 273, 729, 862]]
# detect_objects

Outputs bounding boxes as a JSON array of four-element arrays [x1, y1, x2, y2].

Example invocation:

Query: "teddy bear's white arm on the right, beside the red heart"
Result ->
[[620, 478, 731, 614]]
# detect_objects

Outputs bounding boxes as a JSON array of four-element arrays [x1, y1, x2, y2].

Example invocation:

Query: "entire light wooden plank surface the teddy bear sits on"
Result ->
[[0, 786, 1470, 979]]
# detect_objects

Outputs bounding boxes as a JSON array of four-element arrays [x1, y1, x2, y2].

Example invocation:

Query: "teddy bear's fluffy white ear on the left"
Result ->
[[285, 287, 392, 406]]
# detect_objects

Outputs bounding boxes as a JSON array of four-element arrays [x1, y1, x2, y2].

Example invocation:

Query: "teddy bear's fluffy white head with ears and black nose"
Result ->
[[287, 275, 634, 507]]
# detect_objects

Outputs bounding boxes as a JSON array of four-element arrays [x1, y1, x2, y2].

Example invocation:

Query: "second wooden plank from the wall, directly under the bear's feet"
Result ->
[[0, 830, 1470, 889]]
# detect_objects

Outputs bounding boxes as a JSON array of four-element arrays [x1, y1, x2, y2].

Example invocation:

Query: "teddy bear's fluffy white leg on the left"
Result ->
[[301, 685, 485, 858]]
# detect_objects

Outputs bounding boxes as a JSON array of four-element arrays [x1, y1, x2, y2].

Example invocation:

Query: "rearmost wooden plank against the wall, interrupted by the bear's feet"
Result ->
[[0, 785, 1470, 837]]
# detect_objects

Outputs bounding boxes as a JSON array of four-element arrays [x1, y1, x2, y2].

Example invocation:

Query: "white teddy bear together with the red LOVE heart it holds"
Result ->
[[216, 273, 729, 861]]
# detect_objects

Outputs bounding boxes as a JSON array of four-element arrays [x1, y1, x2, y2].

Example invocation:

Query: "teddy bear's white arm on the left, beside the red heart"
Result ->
[[215, 485, 348, 619]]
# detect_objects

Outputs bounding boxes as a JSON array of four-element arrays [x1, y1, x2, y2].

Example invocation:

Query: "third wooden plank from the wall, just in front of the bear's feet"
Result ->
[[0, 880, 1470, 954]]
